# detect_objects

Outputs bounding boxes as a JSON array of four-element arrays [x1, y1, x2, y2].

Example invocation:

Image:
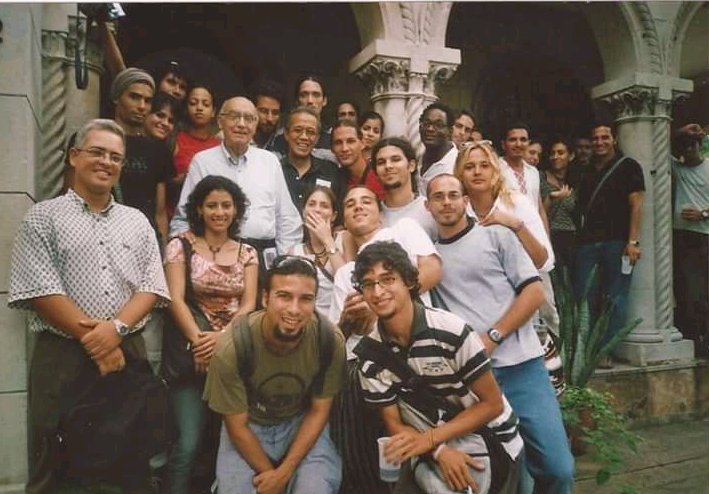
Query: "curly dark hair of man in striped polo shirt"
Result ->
[[352, 241, 421, 300]]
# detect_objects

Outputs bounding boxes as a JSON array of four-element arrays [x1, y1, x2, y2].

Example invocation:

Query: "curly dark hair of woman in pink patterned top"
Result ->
[[186, 175, 249, 239]]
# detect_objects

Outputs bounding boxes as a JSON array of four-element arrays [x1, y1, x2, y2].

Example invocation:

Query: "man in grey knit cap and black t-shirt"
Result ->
[[111, 68, 172, 242]]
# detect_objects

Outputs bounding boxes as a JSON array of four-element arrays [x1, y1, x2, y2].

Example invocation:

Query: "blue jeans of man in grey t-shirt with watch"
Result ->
[[493, 357, 574, 494]]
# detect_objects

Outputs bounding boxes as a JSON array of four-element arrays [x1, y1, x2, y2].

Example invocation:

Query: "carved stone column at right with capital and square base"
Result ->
[[592, 73, 694, 365]]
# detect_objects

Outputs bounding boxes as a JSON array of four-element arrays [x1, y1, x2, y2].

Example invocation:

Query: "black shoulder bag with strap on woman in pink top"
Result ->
[[160, 237, 212, 384]]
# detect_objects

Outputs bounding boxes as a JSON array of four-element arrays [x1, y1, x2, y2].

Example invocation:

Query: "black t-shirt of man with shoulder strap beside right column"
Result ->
[[577, 154, 645, 243]]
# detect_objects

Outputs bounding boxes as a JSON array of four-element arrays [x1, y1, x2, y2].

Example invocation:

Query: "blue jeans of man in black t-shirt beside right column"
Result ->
[[574, 240, 632, 348]]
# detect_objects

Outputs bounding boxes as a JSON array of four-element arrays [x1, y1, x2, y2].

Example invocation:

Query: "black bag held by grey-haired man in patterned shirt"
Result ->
[[58, 357, 168, 479]]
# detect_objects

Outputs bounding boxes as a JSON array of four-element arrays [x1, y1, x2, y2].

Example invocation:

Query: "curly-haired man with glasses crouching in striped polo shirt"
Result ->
[[352, 242, 522, 494]]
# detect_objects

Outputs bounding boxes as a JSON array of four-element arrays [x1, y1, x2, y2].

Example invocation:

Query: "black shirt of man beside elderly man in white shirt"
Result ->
[[281, 156, 344, 214]]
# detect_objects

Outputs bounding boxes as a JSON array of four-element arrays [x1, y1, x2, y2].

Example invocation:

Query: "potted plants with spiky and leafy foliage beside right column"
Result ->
[[552, 272, 641, 492]]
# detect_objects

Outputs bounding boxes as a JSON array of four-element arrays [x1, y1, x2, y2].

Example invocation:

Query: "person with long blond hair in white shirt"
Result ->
[[454, 141, 554, 271]]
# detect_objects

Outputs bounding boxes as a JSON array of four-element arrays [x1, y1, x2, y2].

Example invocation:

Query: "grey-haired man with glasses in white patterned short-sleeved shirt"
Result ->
[[8, 120, 169, 494]]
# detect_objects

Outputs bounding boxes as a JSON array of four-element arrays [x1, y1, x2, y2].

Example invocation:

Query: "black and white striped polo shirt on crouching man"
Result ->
[[354, 303, 522, 459]]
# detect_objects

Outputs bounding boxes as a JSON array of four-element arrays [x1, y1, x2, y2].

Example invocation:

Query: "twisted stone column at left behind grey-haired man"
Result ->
[[35, 5, 102, 200]]
